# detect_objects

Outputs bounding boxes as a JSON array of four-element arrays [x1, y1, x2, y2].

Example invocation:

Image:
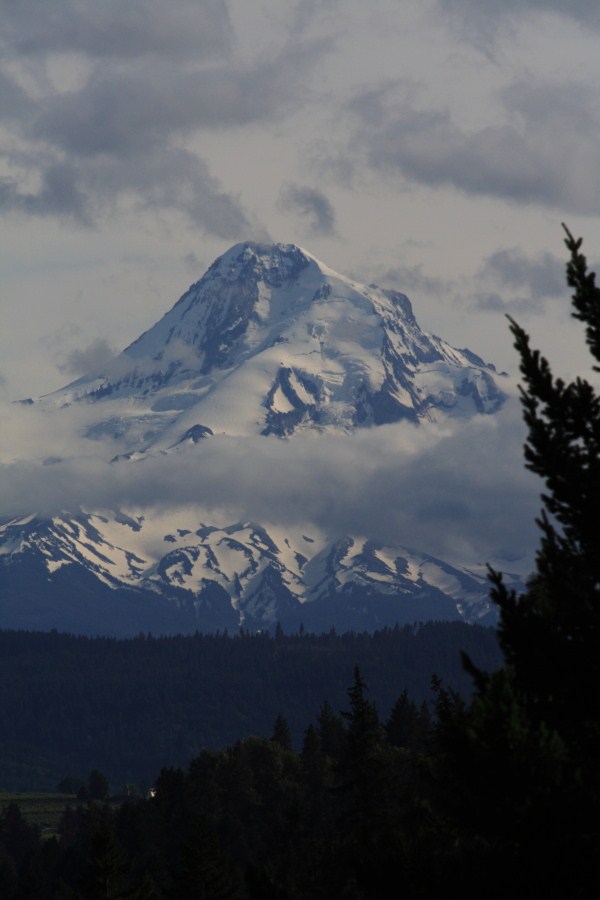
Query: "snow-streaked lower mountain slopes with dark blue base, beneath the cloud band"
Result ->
[[0, 511, 504, 636]]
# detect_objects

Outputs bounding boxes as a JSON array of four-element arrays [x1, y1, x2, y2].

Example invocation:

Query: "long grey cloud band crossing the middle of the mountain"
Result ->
[[3, 402, 540, 564]]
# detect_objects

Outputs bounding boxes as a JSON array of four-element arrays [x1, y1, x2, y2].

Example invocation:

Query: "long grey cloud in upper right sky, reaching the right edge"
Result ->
[[351, 81, 600, 214]]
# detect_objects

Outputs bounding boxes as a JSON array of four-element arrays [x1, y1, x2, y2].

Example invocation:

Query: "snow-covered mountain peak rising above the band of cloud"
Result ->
[[48, 242, 504, 452]]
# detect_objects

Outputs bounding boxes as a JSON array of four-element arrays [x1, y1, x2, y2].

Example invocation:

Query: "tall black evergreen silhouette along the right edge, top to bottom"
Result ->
[[438, 229, 600, 897]]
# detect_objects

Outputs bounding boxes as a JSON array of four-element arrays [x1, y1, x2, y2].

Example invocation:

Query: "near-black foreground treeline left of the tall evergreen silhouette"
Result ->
[[0, 667, 474, 900]]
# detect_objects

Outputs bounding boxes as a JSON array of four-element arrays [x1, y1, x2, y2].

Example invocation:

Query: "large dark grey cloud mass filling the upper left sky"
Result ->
[[0, 0, 330, 240]]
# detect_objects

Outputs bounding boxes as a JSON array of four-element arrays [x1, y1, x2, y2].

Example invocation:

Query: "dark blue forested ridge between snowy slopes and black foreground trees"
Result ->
[[0, 622, 500, 791]]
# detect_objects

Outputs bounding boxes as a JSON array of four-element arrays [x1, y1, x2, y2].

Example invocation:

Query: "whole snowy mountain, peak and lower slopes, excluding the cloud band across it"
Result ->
[[0, 242, 516, 635]]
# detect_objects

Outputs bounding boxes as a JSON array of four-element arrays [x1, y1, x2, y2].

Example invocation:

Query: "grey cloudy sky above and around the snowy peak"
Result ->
[[0, 0, 600, 568]]
